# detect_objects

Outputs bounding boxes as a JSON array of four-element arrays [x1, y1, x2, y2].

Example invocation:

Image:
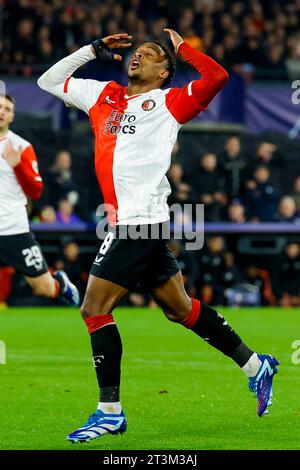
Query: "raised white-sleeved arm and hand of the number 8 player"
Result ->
[[37, 33, 131, 113]]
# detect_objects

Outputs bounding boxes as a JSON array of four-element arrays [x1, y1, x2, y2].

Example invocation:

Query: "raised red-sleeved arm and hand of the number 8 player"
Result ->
[[165, 29, 228, 124]]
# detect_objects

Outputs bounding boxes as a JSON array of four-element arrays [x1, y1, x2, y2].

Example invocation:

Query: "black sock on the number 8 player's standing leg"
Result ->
[[91, 324, 122, 402]]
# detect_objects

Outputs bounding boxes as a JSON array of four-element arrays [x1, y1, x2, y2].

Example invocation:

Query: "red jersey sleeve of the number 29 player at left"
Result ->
[[14, 145, 43, 199]]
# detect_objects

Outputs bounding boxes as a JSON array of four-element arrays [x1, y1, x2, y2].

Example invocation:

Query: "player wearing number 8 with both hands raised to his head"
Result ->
[[38, 29, 278, 442]]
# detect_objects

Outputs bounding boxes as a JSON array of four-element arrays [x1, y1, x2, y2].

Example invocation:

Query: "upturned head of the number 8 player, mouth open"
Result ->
[[128, 42, 168, 83]]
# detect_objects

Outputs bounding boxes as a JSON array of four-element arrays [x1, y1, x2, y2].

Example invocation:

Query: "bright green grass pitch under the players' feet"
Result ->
[[0, 308, 300, 450]]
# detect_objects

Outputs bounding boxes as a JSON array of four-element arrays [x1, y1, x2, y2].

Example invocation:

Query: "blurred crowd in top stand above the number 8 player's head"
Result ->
[[0, 0, 300, 79]]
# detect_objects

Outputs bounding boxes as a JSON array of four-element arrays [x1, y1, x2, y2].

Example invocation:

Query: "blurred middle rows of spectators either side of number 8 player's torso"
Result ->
[[27, 135, 300, 224]]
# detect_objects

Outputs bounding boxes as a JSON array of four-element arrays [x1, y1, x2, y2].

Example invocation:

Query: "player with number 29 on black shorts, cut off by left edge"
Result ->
[[0, 95, 79, 305]]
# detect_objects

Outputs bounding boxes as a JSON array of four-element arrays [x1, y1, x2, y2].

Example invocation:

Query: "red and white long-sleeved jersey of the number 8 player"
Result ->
[[38, 43, 228, 225]]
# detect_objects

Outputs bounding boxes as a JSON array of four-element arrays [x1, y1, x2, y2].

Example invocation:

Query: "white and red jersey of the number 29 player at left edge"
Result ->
[[0, 130, 43, 236]]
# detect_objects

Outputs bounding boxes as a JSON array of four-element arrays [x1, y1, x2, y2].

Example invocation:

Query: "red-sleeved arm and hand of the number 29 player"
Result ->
[[2, 141, 43, 199]]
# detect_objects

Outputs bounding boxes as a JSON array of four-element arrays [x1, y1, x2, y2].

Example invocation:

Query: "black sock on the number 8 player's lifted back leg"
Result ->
[[191, 302, 254, 367]]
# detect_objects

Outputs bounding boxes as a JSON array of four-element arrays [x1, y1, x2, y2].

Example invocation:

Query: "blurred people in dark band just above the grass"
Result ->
[[0, 235, 300, 307]]
